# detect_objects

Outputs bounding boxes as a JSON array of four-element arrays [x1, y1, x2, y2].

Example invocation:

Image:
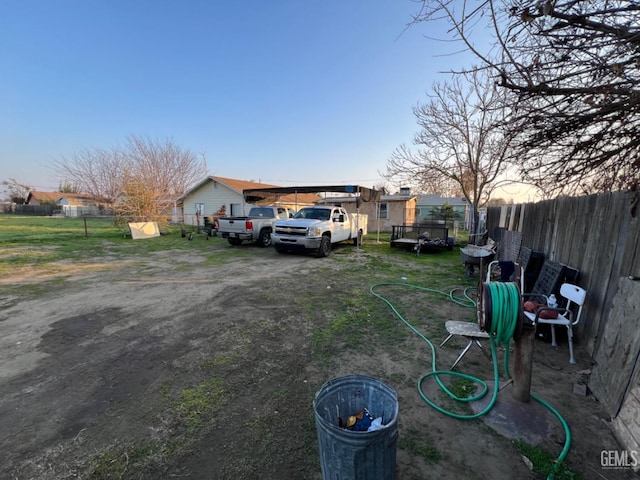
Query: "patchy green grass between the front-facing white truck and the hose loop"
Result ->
[[304, 248, 473, 365]]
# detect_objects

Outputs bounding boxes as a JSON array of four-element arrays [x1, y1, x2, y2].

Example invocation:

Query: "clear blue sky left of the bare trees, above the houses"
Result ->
[[0, 0, 480, 190]]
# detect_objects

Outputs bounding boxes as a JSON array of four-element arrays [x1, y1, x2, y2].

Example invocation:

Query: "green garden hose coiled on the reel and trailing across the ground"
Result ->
[[370, 282, 571, 480]]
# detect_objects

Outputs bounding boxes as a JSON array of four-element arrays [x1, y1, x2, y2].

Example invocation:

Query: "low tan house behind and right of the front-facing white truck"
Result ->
[[316, 188, 418, 233]]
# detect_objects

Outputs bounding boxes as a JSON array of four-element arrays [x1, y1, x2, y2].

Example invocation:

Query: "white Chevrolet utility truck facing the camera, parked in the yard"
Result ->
[[271, 206, 368, 257]]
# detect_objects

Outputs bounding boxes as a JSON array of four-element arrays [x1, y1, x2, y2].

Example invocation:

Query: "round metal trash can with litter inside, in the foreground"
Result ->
[[313, 375, 398, 480]]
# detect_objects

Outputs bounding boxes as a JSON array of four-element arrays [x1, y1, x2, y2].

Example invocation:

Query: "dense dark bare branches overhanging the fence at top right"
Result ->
[[414, 0, 640, 193]]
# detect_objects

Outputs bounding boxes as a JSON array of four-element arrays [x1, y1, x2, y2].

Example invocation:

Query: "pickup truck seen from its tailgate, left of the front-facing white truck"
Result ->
[[218, 205, 295, 247]]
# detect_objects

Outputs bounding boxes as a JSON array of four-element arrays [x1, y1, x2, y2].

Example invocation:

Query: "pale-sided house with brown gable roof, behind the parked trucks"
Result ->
[[172, 176, 319, 225]]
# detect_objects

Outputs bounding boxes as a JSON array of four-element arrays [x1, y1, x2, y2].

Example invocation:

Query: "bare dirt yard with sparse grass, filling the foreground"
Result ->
[[0, 239, 635, 480]]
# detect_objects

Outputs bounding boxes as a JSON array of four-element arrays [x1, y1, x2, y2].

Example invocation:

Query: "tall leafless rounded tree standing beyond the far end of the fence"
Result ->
[[383, 72, 510, 234]]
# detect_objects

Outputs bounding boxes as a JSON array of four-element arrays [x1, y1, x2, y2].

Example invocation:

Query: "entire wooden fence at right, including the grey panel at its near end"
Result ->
[[487, 191, 640, 438]]
